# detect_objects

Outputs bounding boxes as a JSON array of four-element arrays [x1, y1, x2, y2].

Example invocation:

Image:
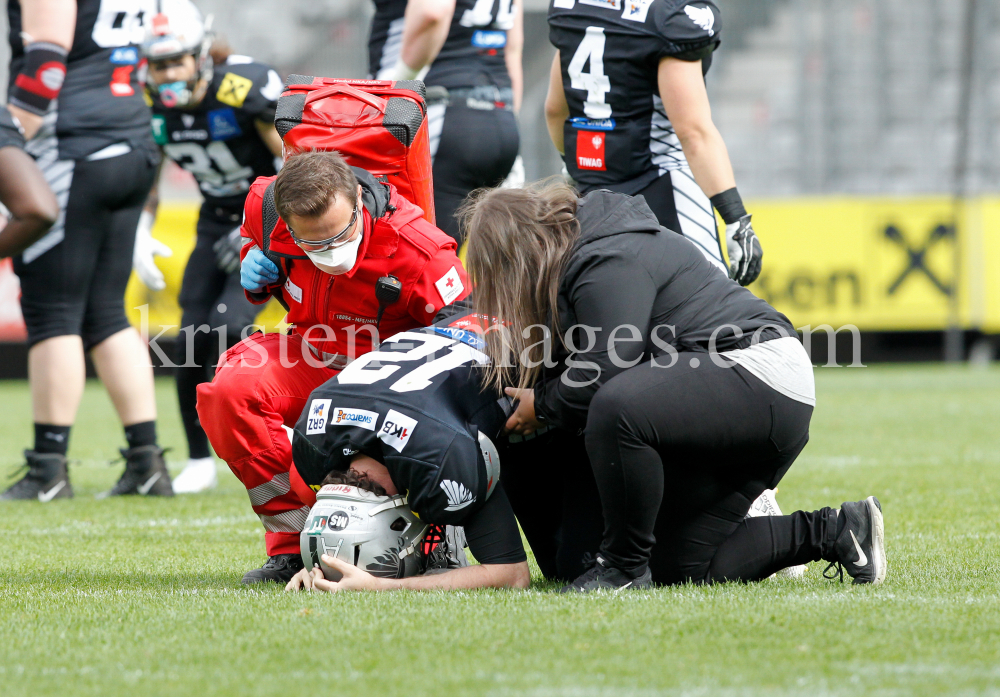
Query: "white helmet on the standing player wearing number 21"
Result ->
[[142, 0, 215, 108]]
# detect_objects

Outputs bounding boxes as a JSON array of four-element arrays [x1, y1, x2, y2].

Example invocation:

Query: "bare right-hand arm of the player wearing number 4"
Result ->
[[657, 56, 736, 198]]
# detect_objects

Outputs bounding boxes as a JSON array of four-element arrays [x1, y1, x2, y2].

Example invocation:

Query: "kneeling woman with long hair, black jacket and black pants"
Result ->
[[463, 184, 886, 591]]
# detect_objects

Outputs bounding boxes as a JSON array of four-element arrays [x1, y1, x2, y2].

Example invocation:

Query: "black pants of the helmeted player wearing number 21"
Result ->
[[175, 215, 261, 458]]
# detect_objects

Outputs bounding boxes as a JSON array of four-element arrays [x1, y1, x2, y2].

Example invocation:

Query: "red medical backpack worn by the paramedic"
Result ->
[[274, 75, 434, 224]]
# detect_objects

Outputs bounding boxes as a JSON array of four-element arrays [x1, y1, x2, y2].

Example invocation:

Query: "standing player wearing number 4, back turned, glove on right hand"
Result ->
[[545, 0, 763, 286]]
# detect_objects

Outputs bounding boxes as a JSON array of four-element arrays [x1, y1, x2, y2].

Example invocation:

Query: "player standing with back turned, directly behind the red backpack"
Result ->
[[368, 0, 524, 245]]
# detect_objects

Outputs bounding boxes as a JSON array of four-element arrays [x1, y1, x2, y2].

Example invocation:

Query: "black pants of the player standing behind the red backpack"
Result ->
[[428, 104, 520, 245]]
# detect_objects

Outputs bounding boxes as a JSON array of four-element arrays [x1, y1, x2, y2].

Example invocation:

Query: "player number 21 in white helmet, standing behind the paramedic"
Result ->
[[135, 0, 282, 493]]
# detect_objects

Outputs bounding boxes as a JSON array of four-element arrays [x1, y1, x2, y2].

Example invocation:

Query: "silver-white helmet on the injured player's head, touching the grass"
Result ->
[[299, 484, 428, 581]]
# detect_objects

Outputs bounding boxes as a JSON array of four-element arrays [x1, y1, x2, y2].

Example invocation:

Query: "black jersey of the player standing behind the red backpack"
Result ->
[[368, 0, 521, 89]]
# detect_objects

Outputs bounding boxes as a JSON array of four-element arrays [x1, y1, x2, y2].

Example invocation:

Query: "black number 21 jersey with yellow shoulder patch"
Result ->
[[153, 56, 282, 213]]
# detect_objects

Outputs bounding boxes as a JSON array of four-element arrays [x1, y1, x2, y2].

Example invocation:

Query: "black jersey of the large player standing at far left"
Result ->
[[7, 0, 155, 160]]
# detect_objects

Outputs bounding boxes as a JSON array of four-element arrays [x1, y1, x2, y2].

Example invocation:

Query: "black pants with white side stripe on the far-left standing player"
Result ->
[[14, 150, 154, 350]]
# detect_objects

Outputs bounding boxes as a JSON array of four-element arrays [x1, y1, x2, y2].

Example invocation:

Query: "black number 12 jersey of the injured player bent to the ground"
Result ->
[[292, 318, 507, 525]]
